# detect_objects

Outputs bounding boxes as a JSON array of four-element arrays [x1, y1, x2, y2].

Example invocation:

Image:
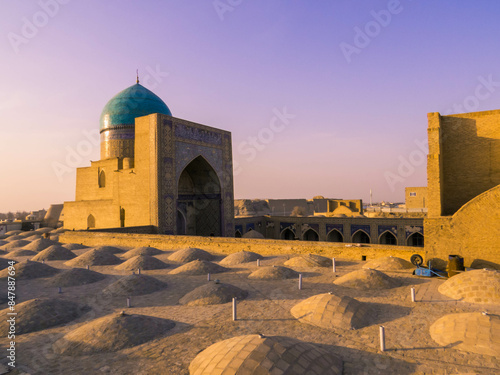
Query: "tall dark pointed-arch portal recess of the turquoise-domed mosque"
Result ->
[[177, 156, 222, 236]]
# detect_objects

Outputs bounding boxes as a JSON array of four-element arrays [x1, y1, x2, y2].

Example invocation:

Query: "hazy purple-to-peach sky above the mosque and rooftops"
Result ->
[[0, 0, 500, 212]]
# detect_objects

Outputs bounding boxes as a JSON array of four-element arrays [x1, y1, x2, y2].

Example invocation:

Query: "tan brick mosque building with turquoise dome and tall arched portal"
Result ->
[[64, 79, 234, 236]]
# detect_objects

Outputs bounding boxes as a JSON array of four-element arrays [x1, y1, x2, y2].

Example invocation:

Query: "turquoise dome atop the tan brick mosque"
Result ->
[[100, 83, 172, 132]]
